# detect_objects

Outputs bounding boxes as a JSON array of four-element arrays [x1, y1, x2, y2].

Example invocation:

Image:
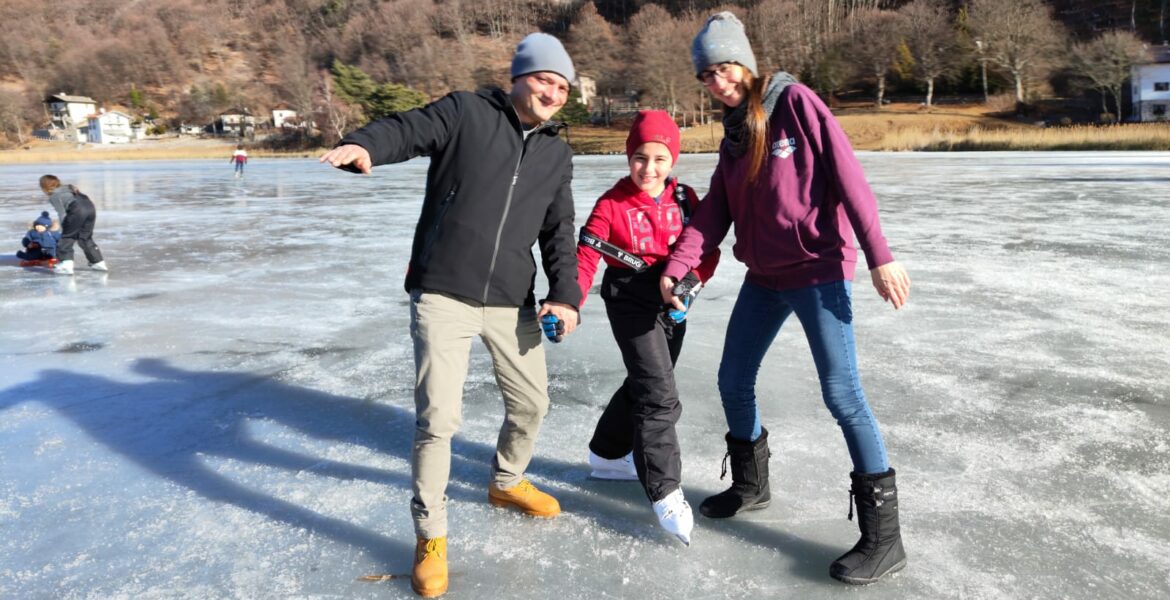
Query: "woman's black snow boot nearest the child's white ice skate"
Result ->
[[698, 429, 772, 519]]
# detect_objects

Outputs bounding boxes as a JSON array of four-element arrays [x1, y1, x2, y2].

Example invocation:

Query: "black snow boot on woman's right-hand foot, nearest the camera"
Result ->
[[828, 469, 906, 585]]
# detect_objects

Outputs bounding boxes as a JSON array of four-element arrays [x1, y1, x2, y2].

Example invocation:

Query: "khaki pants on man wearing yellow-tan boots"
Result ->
[[411, 290, 549, 538]]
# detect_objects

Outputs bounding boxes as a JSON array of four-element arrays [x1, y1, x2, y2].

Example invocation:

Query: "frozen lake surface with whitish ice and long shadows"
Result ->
[[0, 153, 1170, 600]]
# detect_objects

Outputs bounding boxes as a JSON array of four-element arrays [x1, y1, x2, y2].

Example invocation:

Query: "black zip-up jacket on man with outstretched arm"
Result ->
[[338, 89, 580, 308]]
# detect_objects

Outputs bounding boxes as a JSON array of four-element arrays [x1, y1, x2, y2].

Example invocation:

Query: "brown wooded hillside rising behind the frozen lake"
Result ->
[[0, 0, 1170, 143]]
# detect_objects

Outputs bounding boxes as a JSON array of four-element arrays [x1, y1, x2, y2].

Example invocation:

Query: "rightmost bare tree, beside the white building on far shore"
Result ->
[[1071, 29, 1145, 123]]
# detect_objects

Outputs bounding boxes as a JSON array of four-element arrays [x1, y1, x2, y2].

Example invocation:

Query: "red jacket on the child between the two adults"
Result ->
[[577, 175, 720, 305]]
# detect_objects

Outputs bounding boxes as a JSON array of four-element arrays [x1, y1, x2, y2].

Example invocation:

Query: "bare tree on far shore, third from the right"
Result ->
[[899, 0, 962, 106]]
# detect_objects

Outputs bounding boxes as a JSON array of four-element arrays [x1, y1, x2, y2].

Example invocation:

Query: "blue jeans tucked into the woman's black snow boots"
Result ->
[[718, 281, 889, 474]]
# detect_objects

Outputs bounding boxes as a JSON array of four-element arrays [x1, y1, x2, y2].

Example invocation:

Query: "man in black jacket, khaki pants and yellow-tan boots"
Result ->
[[321, 34, 580, 596]]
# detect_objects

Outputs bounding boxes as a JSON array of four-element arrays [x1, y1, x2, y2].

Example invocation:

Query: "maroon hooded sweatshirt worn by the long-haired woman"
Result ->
[[663, 83, 894, 290]]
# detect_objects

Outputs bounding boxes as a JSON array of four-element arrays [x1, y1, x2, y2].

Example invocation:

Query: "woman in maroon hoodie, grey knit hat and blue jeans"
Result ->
[[660, 13, 910, 584]]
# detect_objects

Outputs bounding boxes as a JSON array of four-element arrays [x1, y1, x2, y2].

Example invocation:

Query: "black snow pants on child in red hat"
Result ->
[[590, 267, 687, 502]]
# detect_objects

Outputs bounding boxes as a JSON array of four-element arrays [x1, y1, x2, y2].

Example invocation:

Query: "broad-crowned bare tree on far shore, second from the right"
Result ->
[[968, 0, 1065, 103]]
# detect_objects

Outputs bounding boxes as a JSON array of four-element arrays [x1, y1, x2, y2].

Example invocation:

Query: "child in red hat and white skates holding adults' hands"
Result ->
[[577, 110, 718, 545]]
